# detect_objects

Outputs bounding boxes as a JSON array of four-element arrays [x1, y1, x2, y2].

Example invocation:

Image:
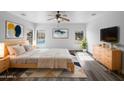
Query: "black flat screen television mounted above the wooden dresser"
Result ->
[[100, 26, 119, 43]]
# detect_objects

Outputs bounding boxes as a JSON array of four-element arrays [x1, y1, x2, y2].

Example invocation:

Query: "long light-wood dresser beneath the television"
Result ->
[[93, 46, 121, 73]]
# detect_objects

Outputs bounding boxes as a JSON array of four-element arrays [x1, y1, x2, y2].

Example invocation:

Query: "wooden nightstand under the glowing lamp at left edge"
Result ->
[[0, 56, 10, 73]]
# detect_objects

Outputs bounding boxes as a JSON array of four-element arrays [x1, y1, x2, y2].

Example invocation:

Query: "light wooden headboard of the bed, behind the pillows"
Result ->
[[4, 40, 29, 56]]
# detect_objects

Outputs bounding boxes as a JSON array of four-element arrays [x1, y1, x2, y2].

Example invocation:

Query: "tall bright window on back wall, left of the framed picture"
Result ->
[[37, 30, 45, 47]]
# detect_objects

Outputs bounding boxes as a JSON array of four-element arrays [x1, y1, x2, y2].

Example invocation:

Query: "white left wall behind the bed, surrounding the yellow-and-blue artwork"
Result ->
[[0, 12, 34, 42]]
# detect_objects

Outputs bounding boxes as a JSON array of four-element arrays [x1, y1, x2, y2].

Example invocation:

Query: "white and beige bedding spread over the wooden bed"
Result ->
[[10, 49, 72, 69]]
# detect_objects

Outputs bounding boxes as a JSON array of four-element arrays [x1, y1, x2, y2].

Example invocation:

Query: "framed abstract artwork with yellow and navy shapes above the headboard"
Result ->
[[5, 20, 24, 39]]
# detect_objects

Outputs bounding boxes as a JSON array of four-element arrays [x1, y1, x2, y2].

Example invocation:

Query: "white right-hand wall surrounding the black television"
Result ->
[[86, 12, 124, 73]]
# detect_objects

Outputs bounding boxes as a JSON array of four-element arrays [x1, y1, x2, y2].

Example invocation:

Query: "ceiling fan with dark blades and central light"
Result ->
[[48, 11, 70, 23]]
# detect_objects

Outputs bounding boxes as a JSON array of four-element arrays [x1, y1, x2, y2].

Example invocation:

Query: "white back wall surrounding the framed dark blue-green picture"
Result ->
[[36, 23, 86, 49]]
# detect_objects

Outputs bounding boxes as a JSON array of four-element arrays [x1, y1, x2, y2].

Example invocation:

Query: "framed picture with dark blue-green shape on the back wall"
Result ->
[[52, 28, 69, 39]]
